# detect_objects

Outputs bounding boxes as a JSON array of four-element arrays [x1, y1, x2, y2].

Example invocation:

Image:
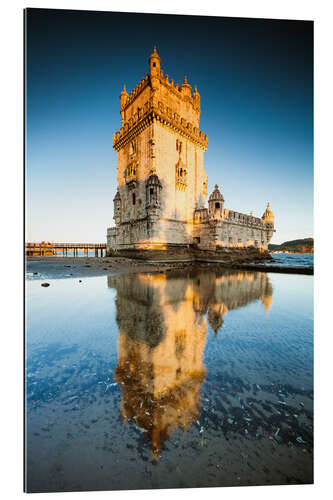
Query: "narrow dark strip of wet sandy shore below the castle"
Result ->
[[26, 257, 313, 279]]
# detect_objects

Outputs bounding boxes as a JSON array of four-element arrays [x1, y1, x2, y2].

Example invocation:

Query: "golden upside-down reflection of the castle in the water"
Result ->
[[108, 272, 272, 460]]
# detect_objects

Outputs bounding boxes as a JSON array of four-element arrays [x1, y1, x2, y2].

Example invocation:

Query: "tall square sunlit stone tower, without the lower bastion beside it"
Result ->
[[108, 47, 208, 249]]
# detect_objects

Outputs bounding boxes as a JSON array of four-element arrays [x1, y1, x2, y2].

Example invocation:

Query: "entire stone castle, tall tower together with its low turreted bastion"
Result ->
[[107, 47, 275, 255]]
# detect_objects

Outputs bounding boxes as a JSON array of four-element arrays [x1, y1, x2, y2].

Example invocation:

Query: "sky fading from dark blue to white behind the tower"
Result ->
[[26, 9, 313, 243]]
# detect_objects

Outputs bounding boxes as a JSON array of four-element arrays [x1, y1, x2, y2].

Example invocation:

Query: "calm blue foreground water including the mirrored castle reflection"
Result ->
[[26, 271, 313, 492]]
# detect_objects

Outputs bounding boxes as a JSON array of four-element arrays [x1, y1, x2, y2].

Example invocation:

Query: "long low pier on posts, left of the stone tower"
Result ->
[[25, 241, 106, 257]]
